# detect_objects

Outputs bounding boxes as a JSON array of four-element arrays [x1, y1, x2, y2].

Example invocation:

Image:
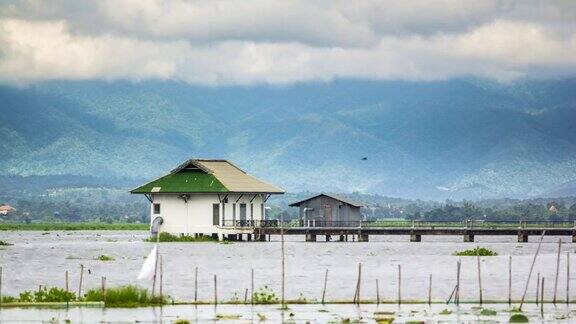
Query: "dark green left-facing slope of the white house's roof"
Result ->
[[130, 170, 229, 194]]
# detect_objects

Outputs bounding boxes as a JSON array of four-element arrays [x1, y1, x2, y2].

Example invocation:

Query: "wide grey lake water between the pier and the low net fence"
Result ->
[[0, 231, 576, 301]]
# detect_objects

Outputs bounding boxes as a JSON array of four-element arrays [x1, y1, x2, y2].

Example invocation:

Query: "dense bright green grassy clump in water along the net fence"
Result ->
[[84, 285, 167, 307]]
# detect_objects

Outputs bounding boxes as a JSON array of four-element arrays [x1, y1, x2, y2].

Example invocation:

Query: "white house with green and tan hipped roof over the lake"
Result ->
[[130, 159, 284, 239]]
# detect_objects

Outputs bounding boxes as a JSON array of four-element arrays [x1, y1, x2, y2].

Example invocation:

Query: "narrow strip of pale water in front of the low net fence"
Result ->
[[0, 304, 574, 323]]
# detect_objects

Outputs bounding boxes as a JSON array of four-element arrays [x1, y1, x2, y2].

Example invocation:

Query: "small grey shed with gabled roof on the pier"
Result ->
[[290, 194, 363, 227]]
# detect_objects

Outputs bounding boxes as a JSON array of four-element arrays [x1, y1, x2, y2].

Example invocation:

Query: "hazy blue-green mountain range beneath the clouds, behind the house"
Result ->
[[0, 79, 576, 199]]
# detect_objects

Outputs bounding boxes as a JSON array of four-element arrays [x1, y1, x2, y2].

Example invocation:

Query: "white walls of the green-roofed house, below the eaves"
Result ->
[[150, 194, 264, 235]]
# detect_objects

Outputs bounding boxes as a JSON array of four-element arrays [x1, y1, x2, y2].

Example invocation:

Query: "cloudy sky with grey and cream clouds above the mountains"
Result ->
[[0, 0, 576, 85]]
